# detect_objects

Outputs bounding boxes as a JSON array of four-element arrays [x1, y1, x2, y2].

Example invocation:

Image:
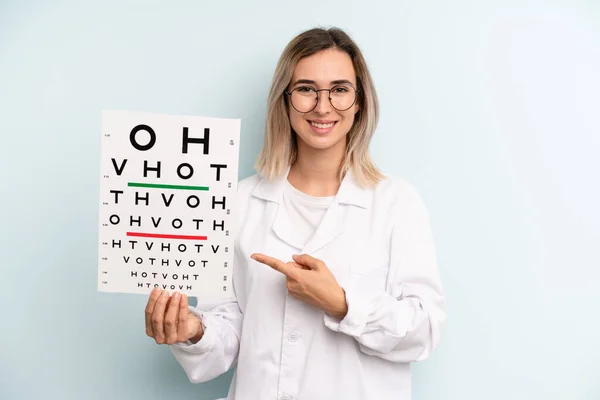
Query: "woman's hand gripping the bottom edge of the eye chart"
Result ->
[[145, 288, 204, 344]]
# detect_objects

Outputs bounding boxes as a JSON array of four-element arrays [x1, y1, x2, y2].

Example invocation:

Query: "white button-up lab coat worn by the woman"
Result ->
[[171, 173, 446, 400]]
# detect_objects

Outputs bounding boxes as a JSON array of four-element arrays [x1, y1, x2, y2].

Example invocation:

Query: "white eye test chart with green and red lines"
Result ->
[[98, 111, 241, 300]]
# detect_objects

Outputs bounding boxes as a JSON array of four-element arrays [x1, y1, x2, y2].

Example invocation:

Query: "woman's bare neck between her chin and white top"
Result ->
[[288, 140, 346, 197]]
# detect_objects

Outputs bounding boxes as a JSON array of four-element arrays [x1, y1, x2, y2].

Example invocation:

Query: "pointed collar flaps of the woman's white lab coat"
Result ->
[[252, 167, 370, 208]]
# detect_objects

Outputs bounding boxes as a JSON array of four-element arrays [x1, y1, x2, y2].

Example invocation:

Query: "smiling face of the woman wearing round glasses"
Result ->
[[288, 49, 358, 152]]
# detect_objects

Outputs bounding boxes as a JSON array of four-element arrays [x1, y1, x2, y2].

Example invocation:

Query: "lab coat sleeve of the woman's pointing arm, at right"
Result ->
[[324, 187, 446, 363]]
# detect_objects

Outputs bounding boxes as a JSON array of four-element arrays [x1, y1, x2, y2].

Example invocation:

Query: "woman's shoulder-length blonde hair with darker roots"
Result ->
[[255, 28, 383, 186]]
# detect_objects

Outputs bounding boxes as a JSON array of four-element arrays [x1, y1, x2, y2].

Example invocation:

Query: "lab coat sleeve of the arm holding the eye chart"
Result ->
[[170, 300, 243, 383]]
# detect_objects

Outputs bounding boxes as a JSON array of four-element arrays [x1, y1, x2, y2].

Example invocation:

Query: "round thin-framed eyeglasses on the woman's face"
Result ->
[[285, 84, 358, 113]]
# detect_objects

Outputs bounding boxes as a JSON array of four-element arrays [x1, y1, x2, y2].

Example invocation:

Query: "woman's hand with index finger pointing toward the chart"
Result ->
[[251, 253, 348, 319]]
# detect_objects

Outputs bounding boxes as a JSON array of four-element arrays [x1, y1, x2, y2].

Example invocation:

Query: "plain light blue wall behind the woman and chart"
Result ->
[[0, 0, 600, 400]]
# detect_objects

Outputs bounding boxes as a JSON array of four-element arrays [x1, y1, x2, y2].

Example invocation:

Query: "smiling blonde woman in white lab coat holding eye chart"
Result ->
[[146, 29, 445, 400]]
